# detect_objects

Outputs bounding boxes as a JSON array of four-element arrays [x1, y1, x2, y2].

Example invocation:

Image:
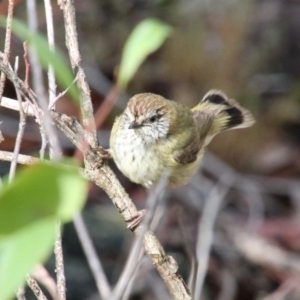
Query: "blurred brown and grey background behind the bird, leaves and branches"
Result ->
[[0, 0, 300, 300]]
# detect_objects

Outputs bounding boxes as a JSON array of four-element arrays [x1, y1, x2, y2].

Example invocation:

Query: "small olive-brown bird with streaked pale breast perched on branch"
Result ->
[[110, 90, 255, 188]]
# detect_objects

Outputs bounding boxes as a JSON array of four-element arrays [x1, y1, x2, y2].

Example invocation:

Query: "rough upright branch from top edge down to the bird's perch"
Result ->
[[60, 0, 98, 148]]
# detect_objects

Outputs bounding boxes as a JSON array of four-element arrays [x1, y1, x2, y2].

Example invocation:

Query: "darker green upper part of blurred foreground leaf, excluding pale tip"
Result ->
[[0, 164, 60, 237]]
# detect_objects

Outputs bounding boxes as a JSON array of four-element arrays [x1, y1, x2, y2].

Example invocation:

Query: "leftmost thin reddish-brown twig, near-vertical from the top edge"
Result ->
[[0, 0, 14, 105]]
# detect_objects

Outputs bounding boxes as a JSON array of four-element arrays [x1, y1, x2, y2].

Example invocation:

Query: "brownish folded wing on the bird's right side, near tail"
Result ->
[[173, 111, 213, 164]]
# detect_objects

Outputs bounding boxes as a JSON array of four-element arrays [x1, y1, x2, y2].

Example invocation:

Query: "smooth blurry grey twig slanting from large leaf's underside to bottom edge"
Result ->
[[73, 214, 111, 300]]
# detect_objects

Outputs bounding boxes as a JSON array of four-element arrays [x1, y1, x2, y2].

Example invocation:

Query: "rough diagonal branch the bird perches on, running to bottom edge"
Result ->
[[0, 59, 191, 300]]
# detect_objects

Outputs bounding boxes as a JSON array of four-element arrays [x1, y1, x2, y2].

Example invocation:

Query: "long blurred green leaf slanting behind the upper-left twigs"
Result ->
[[0, 17, 79, 104]]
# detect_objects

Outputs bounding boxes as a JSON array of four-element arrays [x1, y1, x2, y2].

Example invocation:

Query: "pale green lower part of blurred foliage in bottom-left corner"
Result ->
[[0, 218, 56, 300]]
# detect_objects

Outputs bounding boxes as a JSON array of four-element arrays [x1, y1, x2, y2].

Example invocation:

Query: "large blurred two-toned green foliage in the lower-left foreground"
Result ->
[[0, 163, 87, 300]]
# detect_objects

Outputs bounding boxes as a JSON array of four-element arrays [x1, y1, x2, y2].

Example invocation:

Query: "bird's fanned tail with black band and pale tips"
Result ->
[[192, 90, 255, 138]]
